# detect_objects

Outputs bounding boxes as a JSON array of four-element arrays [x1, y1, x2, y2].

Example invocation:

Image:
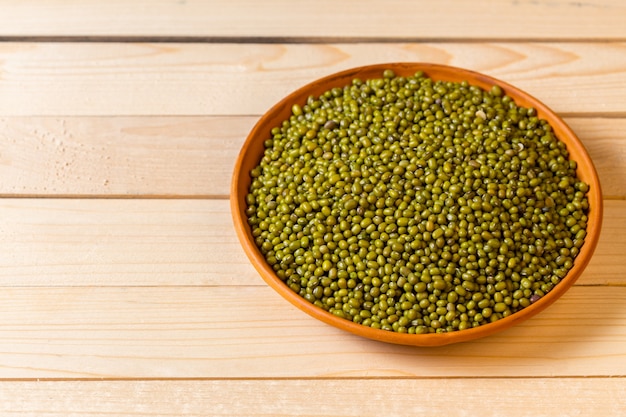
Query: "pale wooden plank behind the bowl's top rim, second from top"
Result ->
[[0, 42, 626, 116]]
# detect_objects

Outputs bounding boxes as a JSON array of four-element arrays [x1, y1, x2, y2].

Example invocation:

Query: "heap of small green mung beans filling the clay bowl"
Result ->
[[246, 70, 589, 334]]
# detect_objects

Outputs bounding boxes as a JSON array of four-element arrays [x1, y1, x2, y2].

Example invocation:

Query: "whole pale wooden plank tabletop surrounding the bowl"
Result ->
[[0, 0, 626, 417]]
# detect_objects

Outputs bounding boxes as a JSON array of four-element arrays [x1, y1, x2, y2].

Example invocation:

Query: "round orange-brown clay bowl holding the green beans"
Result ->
[[230, 63, 603, 346]]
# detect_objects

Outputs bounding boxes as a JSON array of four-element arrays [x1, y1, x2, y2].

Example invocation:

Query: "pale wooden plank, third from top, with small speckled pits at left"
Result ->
[[0, 116, 626, 198]]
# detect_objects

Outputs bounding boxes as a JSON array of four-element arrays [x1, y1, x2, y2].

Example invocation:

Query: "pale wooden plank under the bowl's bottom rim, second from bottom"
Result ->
[[0, 286, 626, 378]]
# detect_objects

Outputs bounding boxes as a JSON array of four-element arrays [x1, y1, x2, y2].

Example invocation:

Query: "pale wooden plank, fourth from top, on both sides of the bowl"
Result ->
[[0, 199, 626, 286]]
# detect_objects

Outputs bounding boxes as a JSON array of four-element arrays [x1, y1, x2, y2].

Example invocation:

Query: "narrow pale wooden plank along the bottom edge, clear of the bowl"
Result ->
[[0, 378, 626, 417]]
